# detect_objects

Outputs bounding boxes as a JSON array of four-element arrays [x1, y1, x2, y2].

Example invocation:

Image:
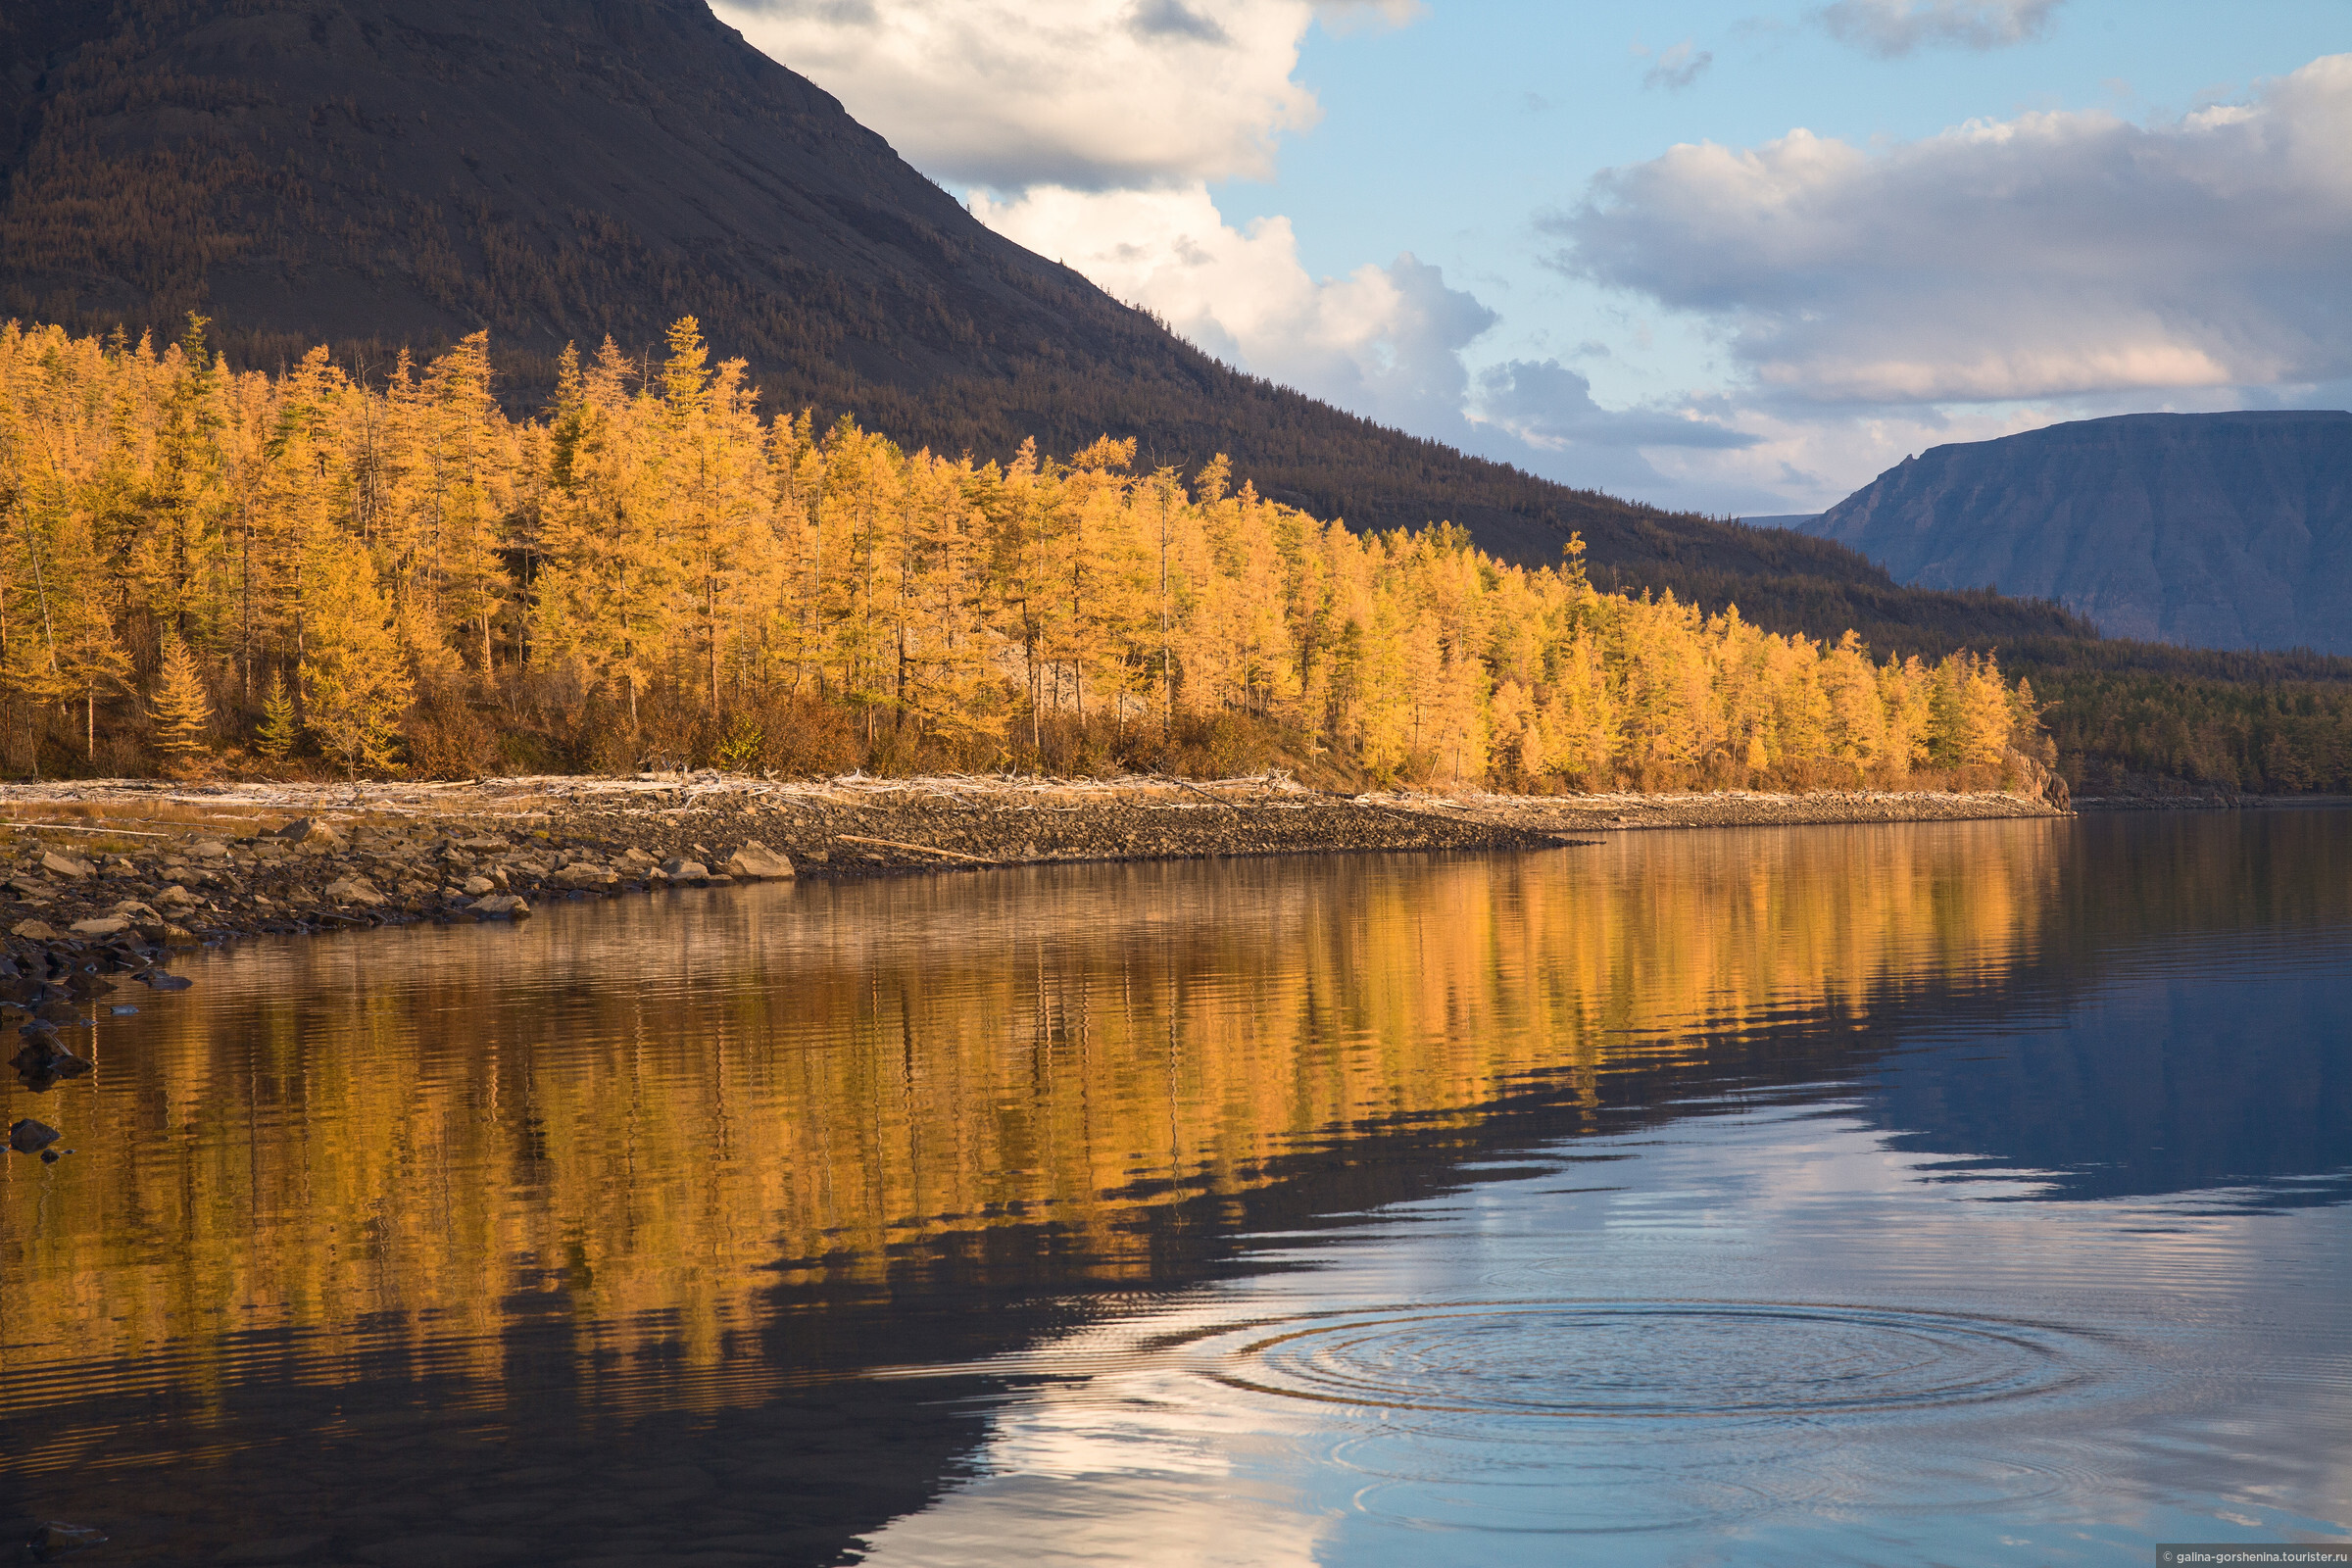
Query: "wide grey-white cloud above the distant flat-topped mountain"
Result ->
[[1547, 54, 2352, 405]]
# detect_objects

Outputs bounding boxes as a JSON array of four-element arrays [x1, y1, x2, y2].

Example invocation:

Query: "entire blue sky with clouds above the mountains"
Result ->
[[717, 0, 2352, 517]]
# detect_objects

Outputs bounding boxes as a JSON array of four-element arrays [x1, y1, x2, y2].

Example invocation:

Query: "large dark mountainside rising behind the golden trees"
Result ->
[[0, 0, 2083, 654]]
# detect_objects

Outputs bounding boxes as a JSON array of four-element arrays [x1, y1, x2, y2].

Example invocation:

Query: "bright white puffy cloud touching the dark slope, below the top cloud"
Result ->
[[971, 186, 1494, 440]]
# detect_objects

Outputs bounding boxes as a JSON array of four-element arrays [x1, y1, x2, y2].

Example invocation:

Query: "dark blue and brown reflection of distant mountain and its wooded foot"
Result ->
[[1868, 811, 2352, 1208]]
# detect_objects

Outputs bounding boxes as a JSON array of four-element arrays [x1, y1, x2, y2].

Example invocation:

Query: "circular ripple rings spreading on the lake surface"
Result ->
[[1209, 1300, 2091, 1420]]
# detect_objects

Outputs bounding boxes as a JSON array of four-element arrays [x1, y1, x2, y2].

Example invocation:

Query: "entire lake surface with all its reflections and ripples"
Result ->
[[0, 811, 2352, 1568]]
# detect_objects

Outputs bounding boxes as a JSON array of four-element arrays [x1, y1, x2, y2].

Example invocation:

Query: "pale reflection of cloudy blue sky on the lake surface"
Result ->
[[868, 1114, 2352, 1563]]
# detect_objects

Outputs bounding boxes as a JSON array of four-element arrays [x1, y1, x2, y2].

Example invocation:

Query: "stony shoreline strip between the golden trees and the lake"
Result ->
[[0, 773, 2058, 1114]]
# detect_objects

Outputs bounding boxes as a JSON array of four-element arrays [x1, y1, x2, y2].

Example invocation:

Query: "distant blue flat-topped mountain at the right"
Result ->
[[1801, 412, 2352, 654]]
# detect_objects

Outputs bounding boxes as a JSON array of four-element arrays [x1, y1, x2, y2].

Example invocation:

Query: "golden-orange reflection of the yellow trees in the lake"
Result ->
[[0, 823, 2065, 1457]]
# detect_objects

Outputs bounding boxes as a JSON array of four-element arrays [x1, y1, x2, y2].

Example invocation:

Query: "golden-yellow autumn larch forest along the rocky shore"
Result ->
[[0, 318, 2046, 788]]
